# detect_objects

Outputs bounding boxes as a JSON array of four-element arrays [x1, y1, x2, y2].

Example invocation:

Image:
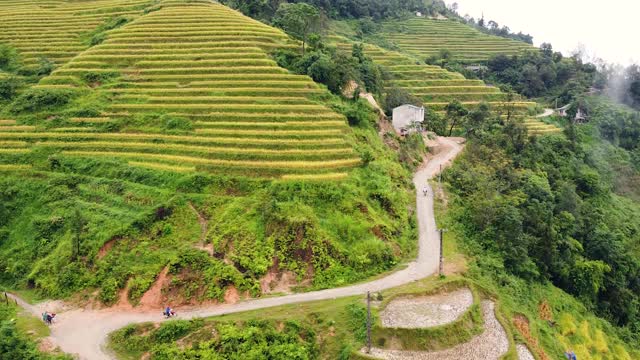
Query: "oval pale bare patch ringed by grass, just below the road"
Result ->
[[380, 288, 473, 329]]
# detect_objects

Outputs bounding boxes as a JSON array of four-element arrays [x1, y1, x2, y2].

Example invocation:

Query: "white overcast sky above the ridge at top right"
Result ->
[[447, 0, 640, 65]]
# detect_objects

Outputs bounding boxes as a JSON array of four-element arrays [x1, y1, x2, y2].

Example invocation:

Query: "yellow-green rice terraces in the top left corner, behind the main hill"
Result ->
[[0, 0, 153, 66]]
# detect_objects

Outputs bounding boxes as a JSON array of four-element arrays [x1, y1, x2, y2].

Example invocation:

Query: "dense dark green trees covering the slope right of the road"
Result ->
[[445, 97, 640, 337]]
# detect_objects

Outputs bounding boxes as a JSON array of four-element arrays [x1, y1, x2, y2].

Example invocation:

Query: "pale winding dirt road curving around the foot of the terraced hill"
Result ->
[[7, 138, 463, 360]]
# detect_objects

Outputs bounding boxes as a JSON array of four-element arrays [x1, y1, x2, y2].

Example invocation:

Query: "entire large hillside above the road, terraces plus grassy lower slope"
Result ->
[[0, 1, 415, 304]]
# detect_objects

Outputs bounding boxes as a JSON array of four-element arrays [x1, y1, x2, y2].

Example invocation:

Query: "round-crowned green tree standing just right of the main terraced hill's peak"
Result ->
[[273, 3, 321, 55]]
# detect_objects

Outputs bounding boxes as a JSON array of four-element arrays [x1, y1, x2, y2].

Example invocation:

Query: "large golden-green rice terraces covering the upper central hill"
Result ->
[[0, 1, 360, 180]]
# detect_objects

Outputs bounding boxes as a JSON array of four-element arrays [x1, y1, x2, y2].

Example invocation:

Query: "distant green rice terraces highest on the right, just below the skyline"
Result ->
[[383, 18, 534, 62]]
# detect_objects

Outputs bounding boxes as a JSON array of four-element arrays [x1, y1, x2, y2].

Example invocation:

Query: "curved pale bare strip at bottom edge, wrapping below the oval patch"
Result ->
[[363, 300, 509, 360]]
